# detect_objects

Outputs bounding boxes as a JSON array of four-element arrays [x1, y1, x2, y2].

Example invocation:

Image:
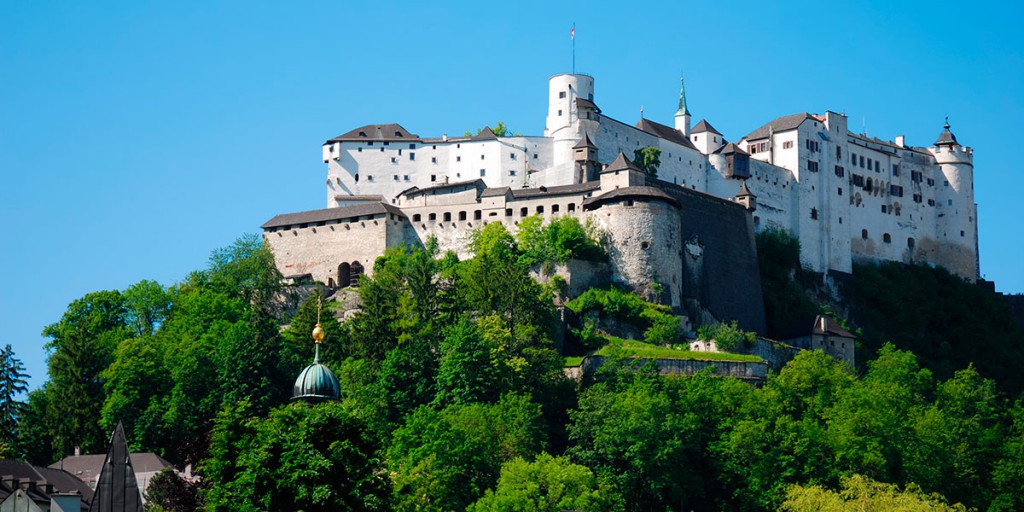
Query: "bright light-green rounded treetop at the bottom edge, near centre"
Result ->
[[468, 453, 624, 512]]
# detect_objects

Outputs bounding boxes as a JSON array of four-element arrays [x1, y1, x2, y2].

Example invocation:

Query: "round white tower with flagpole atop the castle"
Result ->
[[544, 74, 594, 166]]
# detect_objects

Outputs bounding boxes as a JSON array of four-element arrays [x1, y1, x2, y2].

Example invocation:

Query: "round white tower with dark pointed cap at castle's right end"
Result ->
[[930, 120, 979, 279]]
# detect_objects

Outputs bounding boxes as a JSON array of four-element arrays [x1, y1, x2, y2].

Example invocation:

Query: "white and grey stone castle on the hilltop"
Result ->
[[262, 74, 979, 331]]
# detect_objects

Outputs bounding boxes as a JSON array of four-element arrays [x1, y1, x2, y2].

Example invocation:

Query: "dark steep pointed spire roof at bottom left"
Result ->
[[89, 421, 142, 512]]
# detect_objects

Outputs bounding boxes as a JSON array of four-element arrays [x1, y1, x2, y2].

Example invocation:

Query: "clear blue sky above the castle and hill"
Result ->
[[0, 0, 1024, 387]]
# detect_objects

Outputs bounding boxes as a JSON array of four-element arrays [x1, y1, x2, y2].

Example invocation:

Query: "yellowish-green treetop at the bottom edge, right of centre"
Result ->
[[779, 475, 968, 512]]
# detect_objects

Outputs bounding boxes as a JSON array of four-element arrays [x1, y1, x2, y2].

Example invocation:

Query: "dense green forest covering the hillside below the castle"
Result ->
[[0, 219, 1024, 512]]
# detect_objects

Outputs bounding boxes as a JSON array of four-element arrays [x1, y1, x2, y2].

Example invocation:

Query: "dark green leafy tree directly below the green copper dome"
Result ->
[[203, 401, 390, 512]]
